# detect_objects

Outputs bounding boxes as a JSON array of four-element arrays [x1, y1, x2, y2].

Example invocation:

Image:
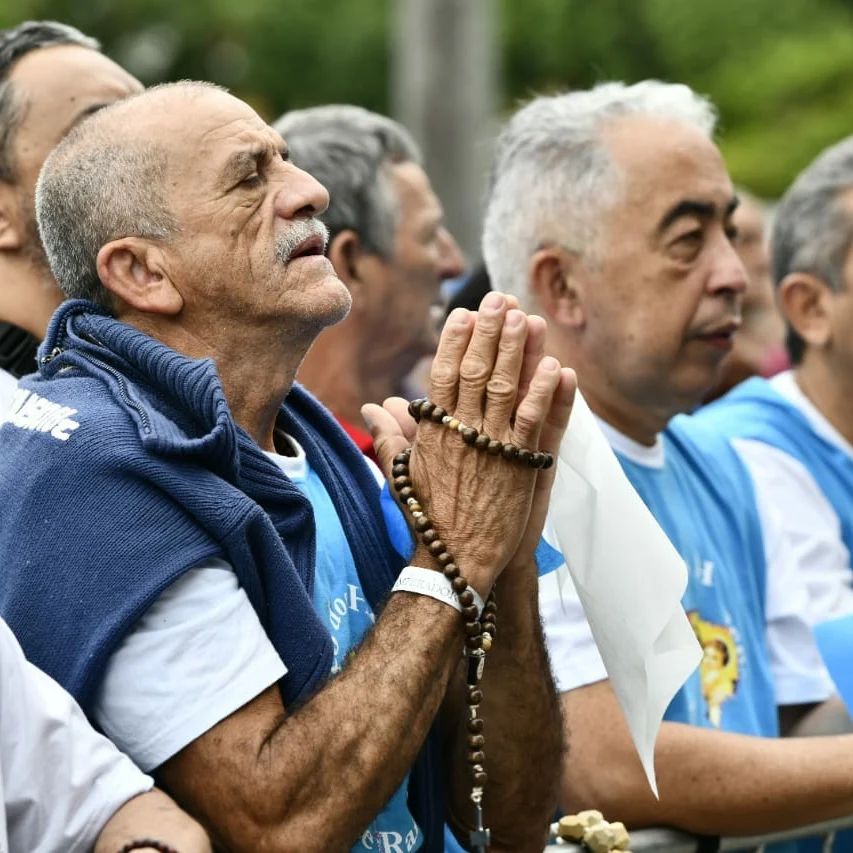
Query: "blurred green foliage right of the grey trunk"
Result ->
[[502, 0, 853, 197]]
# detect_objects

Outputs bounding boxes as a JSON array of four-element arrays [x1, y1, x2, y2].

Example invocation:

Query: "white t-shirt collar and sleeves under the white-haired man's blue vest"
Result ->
[[539, 419, 835, 705]]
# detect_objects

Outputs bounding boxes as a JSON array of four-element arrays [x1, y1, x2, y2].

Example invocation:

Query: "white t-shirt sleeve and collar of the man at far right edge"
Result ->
[[732, 370, 853, 624]]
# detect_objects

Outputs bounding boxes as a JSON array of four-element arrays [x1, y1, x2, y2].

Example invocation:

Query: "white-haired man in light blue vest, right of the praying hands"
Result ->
[[483, 82, 853, 834]]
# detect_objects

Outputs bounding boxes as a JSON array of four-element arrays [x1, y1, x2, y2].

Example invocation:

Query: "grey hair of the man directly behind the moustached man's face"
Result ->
[[273, 104, 421, 258]]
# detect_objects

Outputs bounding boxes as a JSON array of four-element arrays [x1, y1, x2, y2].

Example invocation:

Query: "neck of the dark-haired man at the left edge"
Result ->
[[0, 256, 62, 340]]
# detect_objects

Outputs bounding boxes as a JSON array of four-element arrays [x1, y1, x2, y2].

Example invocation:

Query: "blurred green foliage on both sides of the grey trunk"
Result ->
[[0, 0, 853, 197]]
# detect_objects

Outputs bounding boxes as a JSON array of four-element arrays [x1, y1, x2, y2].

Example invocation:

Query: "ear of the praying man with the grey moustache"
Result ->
[[97, 237, 184, 314]]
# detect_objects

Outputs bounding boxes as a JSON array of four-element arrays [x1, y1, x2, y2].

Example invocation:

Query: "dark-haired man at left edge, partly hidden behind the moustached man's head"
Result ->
[[0, 21, 142, 420]]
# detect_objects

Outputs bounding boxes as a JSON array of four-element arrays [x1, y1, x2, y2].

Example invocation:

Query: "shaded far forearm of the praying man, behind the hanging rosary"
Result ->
[[448, 567, 563, 853]]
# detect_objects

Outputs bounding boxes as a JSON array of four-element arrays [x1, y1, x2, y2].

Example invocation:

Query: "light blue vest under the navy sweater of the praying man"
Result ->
[[290, 463, 423, 853]]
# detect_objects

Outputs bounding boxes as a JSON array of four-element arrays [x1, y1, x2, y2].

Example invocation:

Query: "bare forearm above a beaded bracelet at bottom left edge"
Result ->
[[95, 790, 210, 853]]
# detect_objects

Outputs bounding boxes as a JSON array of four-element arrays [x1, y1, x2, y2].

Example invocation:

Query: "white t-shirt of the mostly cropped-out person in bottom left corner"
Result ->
[[0, 620, 153, 853]]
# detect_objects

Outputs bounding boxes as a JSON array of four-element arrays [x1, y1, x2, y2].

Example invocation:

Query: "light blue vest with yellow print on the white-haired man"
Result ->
[[617, 417, 778, 736]]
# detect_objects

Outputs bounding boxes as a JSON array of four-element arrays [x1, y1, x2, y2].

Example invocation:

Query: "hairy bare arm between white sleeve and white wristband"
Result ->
[[163, 593, 462, 851]]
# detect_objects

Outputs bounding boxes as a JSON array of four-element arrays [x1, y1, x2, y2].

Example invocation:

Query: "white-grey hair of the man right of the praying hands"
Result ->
[[483, 80, 716, 306]]
